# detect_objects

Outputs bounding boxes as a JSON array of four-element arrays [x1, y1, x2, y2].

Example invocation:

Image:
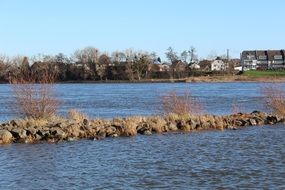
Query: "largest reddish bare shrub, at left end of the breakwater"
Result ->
[[10, 73, 60, 119]]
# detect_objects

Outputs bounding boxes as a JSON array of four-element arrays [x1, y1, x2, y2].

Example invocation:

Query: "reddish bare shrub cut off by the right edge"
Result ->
[[261, 84, 285, 116]]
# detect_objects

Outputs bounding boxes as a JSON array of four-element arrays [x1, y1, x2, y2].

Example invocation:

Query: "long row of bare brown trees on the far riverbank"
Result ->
[[0, 47, 226, 82]]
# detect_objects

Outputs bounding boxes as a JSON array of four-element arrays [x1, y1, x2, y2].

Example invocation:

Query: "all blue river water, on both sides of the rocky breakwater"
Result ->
[[0, 83, 285, 189]]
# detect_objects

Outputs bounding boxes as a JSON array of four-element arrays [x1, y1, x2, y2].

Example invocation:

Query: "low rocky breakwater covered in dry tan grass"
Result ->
[[0, 111, 285, 144]]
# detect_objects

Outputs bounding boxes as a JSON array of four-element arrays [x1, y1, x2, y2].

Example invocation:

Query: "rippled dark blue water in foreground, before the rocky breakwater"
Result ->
[[0, 125, 285, 189]]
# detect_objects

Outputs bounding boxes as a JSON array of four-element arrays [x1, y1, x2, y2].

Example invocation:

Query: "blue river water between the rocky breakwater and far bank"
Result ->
[[0, 83, 278, 121]]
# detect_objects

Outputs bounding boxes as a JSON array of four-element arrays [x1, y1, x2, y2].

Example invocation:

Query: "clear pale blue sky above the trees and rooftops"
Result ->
[[0, 0, 285, 57]]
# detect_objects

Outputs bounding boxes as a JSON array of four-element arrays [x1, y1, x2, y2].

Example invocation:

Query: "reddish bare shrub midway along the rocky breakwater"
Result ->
[[161, 90, 202, 115]]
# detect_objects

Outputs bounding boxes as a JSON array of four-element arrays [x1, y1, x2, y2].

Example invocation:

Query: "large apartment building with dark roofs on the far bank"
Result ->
[[241, 50, 285, 71]]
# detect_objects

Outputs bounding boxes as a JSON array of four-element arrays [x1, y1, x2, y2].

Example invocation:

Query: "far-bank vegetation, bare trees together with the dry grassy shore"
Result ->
[[0, 46, 285, 83]]
